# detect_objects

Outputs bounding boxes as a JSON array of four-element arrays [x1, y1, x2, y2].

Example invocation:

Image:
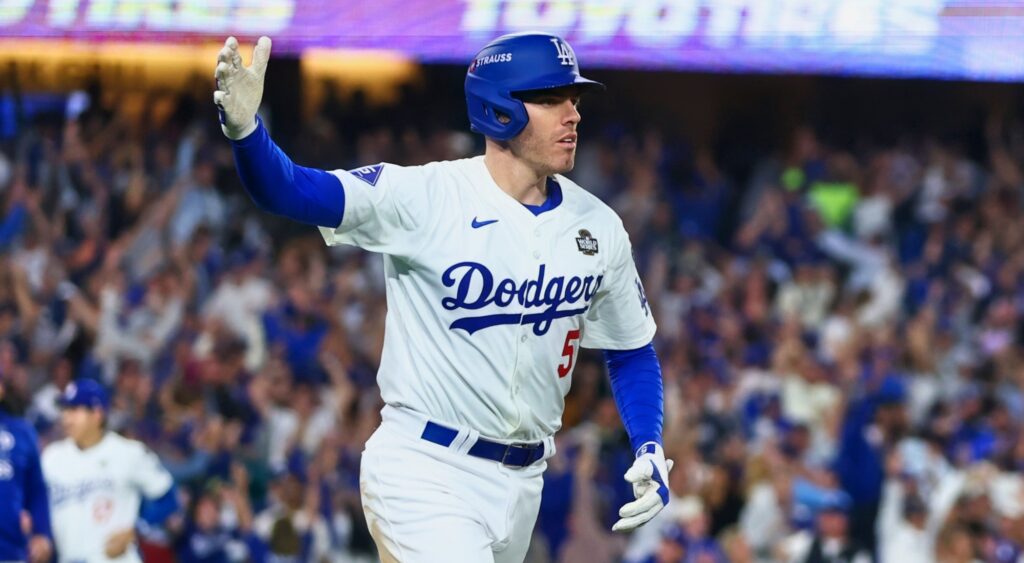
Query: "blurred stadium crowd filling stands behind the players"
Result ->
[[0, 80, 1024, 563]]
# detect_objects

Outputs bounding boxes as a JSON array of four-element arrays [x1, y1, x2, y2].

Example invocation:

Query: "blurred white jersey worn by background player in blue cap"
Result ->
[[42, 432, 173, 563]]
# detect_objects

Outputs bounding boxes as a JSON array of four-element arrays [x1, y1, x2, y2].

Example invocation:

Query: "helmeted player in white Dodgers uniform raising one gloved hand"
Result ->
[[214, 33, 671, 563]]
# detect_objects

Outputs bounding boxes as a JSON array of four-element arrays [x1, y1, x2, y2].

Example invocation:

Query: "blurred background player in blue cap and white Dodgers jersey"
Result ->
[[43, 379, 177, 563]]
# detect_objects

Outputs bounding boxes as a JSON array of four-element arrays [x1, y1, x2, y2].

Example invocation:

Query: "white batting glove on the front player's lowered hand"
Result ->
[[611, 442, 675, 531]]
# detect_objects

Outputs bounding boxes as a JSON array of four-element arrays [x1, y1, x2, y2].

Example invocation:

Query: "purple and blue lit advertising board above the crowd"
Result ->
[[0, 0, 1024, 81]]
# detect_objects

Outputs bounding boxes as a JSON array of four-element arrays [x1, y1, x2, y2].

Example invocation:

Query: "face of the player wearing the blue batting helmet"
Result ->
[[509, 87, 581, 176]]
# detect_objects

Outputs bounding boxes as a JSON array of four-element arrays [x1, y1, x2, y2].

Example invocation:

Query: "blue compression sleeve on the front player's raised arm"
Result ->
[[231, 118, 345, 228]]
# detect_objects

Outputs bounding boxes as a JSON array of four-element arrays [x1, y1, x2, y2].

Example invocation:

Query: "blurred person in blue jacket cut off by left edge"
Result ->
[[0, 376, 52, 561]]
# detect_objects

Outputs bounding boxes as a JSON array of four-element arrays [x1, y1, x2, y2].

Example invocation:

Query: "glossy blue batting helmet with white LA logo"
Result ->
[[466, 32, 604, 140]]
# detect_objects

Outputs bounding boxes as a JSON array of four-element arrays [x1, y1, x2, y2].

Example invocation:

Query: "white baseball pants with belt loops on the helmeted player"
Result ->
[[359, 405, 554, 563]]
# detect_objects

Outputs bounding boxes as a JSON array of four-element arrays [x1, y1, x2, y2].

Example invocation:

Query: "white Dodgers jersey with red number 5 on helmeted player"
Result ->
[[321, 157, 655, 440]]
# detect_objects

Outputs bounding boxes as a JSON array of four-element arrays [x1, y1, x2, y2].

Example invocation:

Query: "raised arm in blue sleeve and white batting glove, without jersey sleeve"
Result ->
[[213, 37, 345, 228]]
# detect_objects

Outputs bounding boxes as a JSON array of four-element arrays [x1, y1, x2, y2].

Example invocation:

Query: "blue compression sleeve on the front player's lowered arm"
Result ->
[[604, 344, 664, 451]]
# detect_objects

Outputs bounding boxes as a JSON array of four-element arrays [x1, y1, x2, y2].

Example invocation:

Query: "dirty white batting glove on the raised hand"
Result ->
[[213, 36, 270, 140]]
